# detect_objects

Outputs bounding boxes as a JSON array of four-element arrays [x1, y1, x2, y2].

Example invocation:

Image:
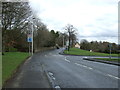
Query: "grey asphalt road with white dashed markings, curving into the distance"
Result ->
[[4, 49, 120, 88]]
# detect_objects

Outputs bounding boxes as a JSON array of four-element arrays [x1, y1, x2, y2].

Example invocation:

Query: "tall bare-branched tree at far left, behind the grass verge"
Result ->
[[2, 2, 31, 51]]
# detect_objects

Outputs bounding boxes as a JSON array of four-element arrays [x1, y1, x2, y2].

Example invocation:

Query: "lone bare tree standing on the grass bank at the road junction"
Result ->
[[65, 24, 77, 51]]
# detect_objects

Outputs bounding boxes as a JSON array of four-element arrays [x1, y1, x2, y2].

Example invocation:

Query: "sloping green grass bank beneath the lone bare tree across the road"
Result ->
[[64, 48, 118, 57]]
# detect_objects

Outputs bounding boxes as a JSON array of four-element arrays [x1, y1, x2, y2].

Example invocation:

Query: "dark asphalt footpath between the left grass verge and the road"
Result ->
[[3, 53, 51, 89]]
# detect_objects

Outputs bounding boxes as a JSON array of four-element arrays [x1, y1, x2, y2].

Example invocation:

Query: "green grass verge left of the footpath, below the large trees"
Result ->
[[2, 52, 29, 84]]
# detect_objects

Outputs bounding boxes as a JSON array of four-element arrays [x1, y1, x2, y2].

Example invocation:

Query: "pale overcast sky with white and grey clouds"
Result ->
[[30, 0, 119, 43]]
